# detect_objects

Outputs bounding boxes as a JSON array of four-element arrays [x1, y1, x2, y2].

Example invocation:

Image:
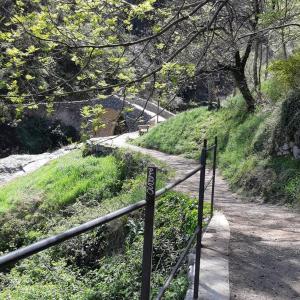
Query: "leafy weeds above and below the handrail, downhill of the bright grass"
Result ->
[[0, 153, 209, 300]]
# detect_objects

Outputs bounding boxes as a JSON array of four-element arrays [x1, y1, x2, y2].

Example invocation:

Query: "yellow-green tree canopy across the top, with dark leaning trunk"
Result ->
[[0, 0, 300, 112]]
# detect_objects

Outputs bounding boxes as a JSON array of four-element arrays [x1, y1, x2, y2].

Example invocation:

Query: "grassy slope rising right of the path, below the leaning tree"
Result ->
[[135, 97, 300, 204]]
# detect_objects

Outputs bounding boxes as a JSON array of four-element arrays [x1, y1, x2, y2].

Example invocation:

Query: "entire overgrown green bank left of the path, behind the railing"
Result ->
[[0, 151, 208, 300]]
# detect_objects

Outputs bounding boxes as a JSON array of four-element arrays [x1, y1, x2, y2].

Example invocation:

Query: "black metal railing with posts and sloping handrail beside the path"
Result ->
[[0, 137, 218, 300]]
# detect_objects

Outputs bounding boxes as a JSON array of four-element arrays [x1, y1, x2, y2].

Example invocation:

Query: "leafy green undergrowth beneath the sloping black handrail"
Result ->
[[0, 192, 209, 300]]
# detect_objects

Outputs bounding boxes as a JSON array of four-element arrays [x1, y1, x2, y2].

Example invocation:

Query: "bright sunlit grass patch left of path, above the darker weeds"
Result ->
[[0, 151, 122, 212]]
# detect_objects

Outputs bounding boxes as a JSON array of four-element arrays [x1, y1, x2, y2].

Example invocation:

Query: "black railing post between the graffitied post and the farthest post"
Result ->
[[194, 140, 207, 299]]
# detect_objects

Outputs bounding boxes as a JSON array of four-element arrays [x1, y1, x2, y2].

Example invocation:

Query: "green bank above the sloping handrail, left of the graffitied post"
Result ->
[[0, 151, 167, 252]]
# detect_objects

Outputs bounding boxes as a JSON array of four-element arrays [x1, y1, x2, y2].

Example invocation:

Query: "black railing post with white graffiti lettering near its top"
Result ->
[[141, 167, 156, 300]]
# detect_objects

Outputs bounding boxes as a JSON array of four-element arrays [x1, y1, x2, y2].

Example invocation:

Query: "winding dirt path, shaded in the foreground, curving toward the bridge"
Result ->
[[99, 134, 300, 300]]
